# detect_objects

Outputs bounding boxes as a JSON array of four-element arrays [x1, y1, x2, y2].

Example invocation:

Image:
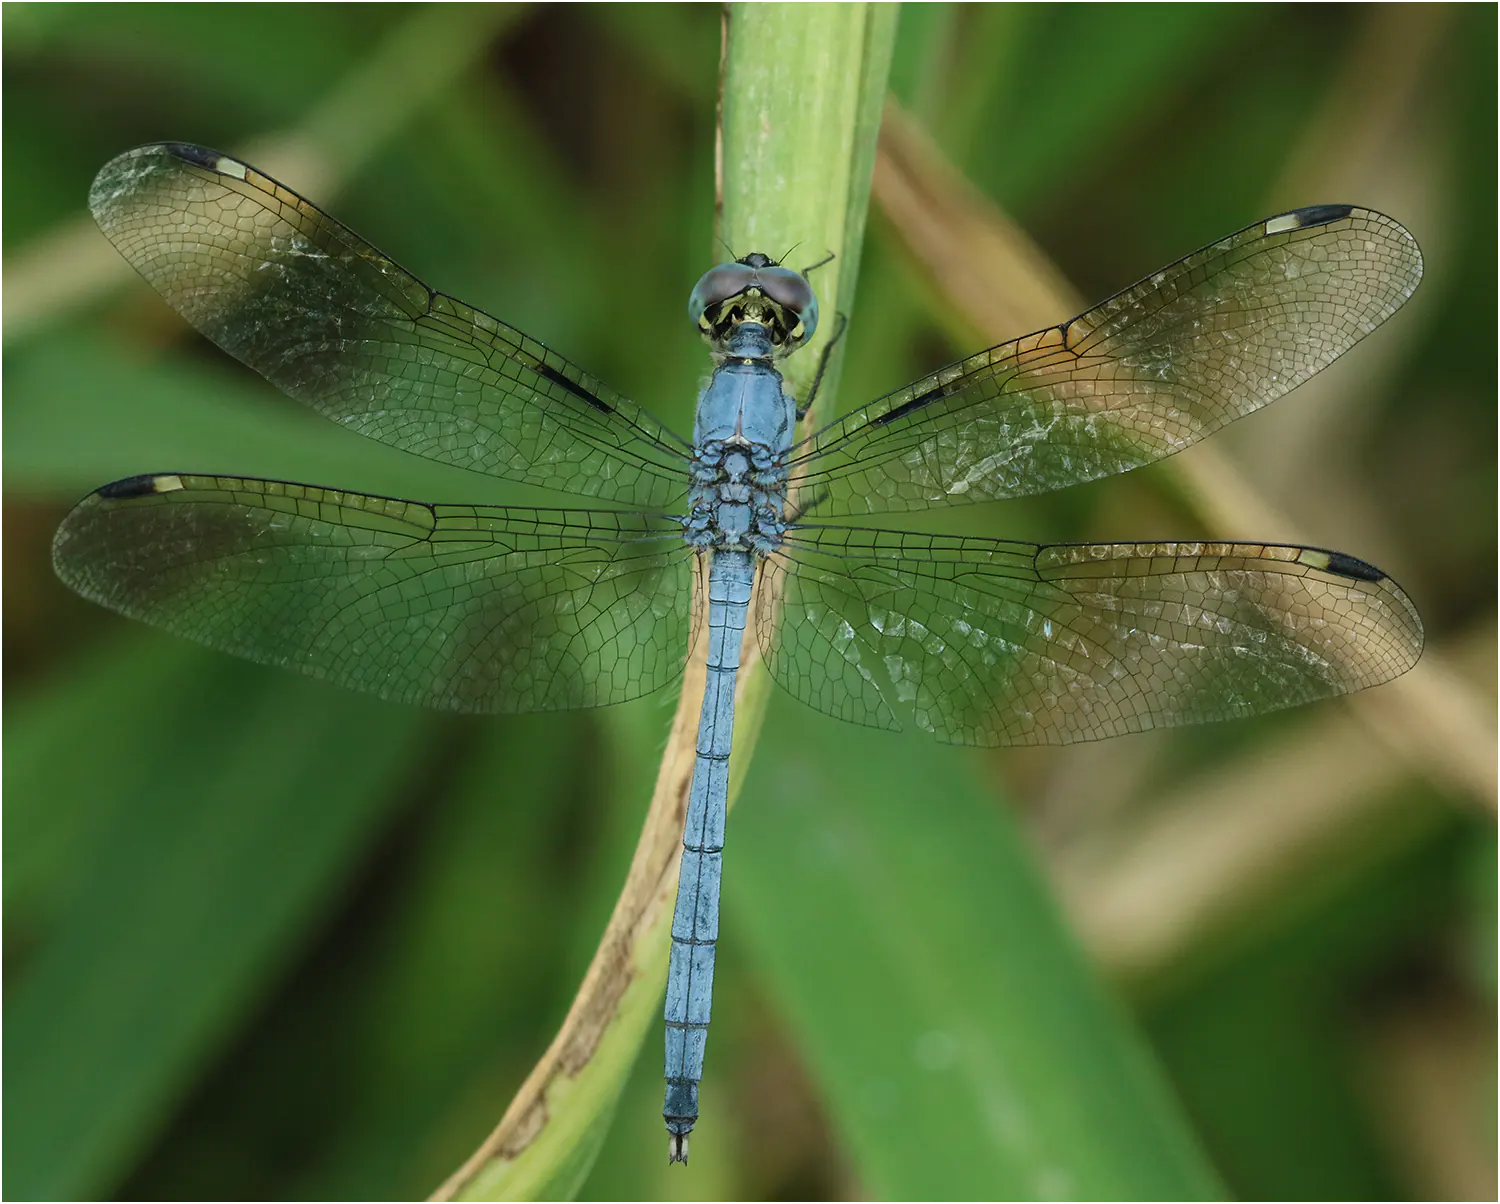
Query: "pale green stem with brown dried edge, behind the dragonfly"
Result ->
[[423, 4, 896, 1200]]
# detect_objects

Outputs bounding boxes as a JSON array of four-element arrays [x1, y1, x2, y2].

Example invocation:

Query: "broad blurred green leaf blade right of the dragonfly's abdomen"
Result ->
[[726, 705, 1223, 1200]]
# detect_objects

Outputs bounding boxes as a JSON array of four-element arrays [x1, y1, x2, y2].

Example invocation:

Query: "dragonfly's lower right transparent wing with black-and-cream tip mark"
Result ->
[[756, 528, 1422, 745]]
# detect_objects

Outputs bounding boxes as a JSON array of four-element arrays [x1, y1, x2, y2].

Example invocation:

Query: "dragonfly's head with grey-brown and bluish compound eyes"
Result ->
[[687, 250, 818, 355]]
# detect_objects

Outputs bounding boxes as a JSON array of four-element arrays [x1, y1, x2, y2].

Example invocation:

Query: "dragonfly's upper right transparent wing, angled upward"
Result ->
[[789, 205, 1422, 514]]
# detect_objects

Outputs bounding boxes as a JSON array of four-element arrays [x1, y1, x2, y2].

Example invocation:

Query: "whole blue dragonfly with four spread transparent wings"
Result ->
[[53, 142, 1422, 1162]]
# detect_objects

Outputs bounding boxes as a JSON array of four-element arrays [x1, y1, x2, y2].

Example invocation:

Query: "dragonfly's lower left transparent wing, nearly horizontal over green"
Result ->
[[53, 474, 696, 712]]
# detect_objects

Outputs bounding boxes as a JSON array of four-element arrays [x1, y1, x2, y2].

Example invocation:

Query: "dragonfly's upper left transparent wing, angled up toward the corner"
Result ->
[[89, 142, 689, 507]]
